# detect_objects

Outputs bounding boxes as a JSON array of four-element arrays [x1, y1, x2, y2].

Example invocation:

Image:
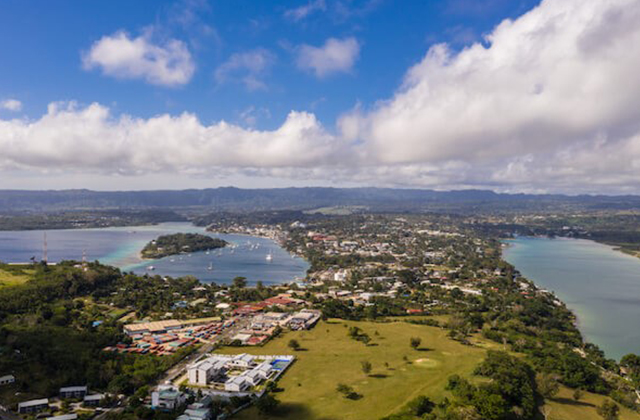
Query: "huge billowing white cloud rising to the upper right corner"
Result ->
[[340, 0, 640, 188]]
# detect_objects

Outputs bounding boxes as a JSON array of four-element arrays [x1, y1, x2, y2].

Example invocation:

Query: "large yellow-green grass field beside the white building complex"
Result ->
[[220, 320, 488, 420]]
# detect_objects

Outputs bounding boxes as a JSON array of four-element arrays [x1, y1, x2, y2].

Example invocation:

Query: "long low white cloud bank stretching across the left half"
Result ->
[[0, 103, 340, 174]]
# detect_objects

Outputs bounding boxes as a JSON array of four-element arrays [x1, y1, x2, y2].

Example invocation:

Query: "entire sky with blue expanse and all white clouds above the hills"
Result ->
[[0, 0, 640, 194]]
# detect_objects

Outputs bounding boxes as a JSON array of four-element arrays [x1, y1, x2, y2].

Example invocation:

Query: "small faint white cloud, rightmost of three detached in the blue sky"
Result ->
[[296, 37, 360, 77]]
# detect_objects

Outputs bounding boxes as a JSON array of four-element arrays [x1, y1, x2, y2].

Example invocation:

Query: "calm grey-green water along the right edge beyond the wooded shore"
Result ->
[[503, 237, 640, 359]]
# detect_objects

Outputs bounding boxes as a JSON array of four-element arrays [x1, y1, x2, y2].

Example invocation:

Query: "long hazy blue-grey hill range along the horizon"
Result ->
[[0, 187, 640, 213]]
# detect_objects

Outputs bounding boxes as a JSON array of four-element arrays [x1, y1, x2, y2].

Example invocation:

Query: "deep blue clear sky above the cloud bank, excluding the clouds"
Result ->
[[0, 0, 536, 128]]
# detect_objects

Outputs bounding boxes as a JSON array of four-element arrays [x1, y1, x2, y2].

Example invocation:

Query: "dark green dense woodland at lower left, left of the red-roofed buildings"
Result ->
[[0, 262, 198, 404]]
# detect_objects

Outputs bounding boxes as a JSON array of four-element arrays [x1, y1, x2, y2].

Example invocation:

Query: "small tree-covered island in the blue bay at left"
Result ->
[[141, 233, 227, 259]]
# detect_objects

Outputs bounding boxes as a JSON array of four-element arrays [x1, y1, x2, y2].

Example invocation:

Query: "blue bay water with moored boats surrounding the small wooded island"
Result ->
[[0, 223, 309, 284]]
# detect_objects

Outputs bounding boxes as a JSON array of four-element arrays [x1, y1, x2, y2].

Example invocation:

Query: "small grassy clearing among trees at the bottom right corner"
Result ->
[[546, 387, 640, 420]]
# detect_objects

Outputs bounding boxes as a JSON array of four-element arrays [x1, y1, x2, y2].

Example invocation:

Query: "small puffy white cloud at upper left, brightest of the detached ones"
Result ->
[[82, 30, 195, 86]]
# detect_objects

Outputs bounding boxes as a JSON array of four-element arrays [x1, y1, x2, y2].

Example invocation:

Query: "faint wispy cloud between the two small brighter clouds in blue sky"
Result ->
[[214, 48, 276, 90]]
